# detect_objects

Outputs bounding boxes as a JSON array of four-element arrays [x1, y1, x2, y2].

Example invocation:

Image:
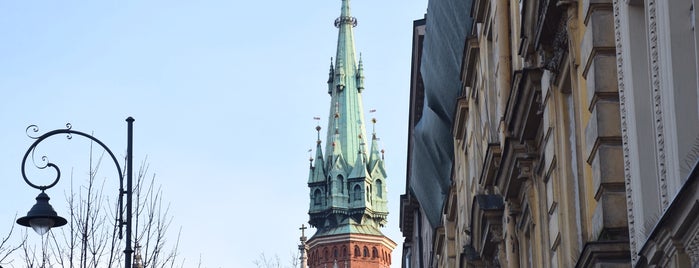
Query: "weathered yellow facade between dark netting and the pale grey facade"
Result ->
[[454, 0, 629, 267]]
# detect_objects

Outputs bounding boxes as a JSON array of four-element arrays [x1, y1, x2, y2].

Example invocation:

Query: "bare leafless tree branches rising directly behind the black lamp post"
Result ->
[[18, 150, 184, 268]]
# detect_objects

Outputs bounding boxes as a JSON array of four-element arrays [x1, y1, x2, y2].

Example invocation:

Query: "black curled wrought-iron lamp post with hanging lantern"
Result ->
[[17, 117, 134, 268]]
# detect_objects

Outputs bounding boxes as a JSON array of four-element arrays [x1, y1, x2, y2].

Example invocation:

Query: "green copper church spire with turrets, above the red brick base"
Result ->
[[308, 0, 388, 236]]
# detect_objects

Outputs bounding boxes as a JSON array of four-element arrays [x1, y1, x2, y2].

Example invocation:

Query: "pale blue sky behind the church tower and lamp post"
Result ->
[[0, 0, 427, 267]]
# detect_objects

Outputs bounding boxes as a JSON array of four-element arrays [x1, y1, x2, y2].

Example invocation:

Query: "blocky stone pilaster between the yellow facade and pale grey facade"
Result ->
[[578, 0, 630, 267]]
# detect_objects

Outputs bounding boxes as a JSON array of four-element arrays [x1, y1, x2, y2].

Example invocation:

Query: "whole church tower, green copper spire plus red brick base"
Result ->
[[307, 0, 396, 268]]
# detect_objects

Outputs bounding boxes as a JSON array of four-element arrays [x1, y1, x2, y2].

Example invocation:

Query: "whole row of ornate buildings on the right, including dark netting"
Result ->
[[401, 0, 699, 267]]
